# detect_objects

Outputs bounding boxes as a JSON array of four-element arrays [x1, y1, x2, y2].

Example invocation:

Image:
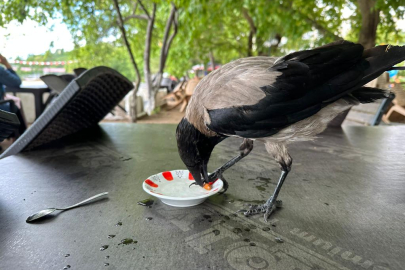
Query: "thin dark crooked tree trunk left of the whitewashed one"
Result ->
[[114, 0, 141, 122]]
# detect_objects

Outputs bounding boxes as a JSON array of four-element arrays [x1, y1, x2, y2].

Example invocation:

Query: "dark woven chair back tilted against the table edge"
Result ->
[[0, 66, 134, 158]]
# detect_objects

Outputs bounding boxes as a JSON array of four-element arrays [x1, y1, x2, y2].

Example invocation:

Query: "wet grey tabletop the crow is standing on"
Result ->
[[0, 124, 405, 270]]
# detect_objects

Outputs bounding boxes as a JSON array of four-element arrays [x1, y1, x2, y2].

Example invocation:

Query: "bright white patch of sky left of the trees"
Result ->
[[0, 19, 74, 60]]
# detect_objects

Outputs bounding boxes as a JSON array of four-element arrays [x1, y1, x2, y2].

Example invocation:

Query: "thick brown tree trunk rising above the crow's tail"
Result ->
[[357, 0, 380, 49]]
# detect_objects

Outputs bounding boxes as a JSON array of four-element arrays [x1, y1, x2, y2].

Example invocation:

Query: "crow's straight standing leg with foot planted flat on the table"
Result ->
[[241, 143, 292, 222]]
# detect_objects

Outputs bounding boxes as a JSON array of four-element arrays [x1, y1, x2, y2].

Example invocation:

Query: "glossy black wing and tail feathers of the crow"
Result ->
[[208, 41, 405, 138]]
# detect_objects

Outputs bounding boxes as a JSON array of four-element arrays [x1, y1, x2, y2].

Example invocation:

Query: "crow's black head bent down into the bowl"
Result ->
[[176, 118, 223, 186]]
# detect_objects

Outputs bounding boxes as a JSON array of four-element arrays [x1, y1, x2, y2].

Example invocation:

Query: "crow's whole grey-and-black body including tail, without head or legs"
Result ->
[[186, 41, 405, 140]]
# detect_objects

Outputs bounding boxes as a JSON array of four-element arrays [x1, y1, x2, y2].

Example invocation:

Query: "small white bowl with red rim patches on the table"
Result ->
[[142, 170, 224, 207]]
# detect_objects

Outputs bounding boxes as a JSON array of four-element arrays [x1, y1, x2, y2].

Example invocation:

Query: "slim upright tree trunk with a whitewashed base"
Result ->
[[143, 3, 156, 115]]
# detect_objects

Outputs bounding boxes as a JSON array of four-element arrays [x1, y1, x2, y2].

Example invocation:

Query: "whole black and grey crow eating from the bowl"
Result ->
[[176, 40, 405, 221]]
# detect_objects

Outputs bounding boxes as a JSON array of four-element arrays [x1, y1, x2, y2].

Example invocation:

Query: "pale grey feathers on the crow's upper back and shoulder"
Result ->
[[186, 56, 281, 136]]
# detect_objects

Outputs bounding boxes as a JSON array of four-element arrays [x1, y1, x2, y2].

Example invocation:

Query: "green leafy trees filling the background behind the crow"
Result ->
[[0, 0, 405, 118]]
